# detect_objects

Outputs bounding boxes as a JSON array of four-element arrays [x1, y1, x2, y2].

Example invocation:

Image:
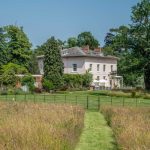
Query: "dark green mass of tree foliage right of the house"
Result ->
[[104, 0, 150, 90]]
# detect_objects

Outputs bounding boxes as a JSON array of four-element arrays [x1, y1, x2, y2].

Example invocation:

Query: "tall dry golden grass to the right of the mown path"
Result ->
[[101, 106, 150, 150]]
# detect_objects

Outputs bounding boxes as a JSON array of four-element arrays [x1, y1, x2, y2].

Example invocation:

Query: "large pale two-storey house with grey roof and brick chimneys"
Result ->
[[37, 46, 122, 88]]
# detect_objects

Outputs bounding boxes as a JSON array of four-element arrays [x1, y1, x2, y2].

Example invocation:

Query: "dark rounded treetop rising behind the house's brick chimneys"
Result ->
[[77, 32, 99, 50]]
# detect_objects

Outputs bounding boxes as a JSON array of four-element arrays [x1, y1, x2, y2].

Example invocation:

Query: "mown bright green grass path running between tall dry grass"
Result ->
[[75, 111, 116, 150]]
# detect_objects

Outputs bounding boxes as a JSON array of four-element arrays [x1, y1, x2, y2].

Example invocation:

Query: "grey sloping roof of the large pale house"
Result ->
[[37, 47, 119, 59]]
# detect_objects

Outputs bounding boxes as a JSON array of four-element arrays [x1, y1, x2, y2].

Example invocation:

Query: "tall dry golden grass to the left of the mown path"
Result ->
[[0, 102, 84, 150]]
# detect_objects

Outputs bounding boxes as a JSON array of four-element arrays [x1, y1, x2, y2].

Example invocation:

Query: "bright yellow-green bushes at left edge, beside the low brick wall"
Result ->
[[0, 63, 28, 87]]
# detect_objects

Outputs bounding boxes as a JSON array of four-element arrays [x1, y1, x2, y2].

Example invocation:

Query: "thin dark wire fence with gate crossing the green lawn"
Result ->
[[0, 94, 150, 109]]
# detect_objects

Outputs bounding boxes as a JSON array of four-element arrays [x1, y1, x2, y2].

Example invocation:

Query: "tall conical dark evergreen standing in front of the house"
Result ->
[[44, 37, 64, 89]]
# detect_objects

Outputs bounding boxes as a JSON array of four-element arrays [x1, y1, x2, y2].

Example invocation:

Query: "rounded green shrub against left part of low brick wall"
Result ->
[[21, 74, 35, 92]]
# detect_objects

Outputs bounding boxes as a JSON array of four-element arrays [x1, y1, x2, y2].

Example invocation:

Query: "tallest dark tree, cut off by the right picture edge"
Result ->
[[131, 0, 150, 90]]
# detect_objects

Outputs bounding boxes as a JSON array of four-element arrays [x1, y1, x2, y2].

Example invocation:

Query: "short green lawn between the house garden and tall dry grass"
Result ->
[[0, 91, 150, 109]]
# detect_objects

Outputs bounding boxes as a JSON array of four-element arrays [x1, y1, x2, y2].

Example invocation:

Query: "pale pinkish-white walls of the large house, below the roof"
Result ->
[[38, 57, 117, 87]]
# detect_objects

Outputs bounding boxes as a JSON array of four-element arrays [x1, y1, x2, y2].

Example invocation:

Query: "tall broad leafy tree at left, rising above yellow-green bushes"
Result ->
[[4, 25, 31, 68]]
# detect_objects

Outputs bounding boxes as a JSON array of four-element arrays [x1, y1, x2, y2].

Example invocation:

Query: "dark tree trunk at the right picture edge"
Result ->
[[144, 64, 150, 91]]
